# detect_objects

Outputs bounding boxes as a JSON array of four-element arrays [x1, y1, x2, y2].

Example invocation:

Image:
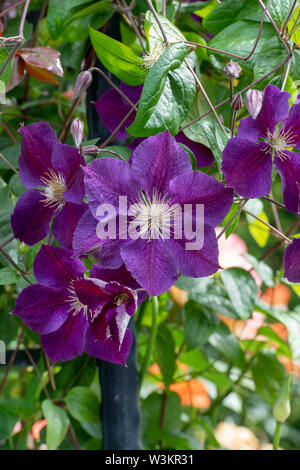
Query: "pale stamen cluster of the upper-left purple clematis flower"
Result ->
[[41, 169, 67, 209]]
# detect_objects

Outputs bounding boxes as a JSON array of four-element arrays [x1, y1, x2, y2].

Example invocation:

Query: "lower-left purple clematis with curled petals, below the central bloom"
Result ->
[[13, 245, 138, 364]]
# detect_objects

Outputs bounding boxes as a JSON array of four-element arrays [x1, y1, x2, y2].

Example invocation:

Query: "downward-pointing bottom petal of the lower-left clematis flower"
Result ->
[[41, 314, 88, 362]]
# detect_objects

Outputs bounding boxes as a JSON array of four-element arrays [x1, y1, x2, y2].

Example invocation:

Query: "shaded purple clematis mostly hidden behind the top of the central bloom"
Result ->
[[94, 83, 214, 168]]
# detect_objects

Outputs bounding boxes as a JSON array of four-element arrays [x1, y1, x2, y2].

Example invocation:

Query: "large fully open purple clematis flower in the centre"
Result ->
[[73, 131, 233, 296]]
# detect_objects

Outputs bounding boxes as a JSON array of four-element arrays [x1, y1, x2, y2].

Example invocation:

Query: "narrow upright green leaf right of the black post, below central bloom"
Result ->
[[156, 323, 176, 389]]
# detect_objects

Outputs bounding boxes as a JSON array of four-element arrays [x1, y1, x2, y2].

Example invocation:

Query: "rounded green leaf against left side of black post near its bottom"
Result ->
[[66, 387, 100, 423]]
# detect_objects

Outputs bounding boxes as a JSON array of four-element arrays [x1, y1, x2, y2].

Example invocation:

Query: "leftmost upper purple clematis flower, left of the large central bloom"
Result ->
[[11, 122, 87, 248]]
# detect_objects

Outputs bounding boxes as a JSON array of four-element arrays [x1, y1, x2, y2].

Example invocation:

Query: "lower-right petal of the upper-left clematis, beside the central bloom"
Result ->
[[53, 202, 88, 250]]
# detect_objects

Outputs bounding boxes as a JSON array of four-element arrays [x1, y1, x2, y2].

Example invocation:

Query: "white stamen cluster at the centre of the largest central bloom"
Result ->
[[130, 190, 181, 240]]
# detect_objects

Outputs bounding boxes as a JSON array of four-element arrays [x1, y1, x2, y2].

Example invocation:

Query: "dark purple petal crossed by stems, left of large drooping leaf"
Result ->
[[94, 83, 142, 140]]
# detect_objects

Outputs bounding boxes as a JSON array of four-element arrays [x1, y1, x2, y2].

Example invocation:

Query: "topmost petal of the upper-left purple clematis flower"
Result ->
[[19, 122, 57, 189]]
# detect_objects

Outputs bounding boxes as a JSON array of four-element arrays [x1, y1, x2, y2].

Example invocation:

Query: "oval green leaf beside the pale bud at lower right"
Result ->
[[252, 352, 286, 404]]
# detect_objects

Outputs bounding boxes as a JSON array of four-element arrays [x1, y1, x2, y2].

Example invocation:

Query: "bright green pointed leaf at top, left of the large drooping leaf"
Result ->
[[90, 28, 147, 85]]
